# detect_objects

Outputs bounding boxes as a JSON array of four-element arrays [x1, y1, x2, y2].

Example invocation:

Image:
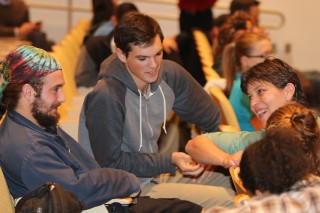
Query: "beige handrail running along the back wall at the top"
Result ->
[[28, 0, 285, 30]]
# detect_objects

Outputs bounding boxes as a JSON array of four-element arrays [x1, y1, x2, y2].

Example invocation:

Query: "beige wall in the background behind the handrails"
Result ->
[[26, 0, 320, 70]]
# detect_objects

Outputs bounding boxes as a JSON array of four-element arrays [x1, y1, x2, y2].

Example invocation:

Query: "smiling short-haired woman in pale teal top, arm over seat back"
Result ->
[[186, 58, 305, 168]]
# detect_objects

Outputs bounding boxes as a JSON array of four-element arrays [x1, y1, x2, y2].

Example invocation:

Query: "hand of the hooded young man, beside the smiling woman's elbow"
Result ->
[[172, 152, 204, 176]]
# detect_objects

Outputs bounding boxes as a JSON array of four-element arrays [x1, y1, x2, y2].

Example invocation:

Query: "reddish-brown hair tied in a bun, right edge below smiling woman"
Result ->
[[266, 104, 320, 176]]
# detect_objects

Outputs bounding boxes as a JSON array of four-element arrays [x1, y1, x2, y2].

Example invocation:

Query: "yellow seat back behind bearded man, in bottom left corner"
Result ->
[[0, 167, 14, 213]]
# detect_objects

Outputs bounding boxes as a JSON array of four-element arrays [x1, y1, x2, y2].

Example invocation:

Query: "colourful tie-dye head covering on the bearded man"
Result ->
[[0, 45, 61, 101]]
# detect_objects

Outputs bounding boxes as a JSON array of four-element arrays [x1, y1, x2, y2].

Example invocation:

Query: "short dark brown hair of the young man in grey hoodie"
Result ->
[[114, 12, 163, 56]]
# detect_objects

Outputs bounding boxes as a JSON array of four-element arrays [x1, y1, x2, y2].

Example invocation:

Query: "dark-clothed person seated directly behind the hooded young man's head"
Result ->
[[75, 3, 138, 88]]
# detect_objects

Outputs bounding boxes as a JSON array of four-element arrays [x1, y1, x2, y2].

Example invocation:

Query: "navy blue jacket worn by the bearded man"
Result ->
[[0, 112, 139, 208]]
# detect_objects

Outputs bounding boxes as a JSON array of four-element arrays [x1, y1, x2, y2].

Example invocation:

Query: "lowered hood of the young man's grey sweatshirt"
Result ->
[[98, 54, 163, 95]]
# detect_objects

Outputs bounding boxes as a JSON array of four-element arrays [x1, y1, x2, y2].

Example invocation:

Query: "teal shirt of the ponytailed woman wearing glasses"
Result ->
[[229, 72, 255, 132]]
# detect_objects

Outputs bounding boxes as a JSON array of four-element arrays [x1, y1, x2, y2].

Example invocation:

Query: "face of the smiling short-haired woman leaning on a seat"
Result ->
[[248, 81, 293, 126]]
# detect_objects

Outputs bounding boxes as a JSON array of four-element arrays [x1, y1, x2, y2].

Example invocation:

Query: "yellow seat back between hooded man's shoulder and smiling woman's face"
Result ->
[[209, 86, 240, 131]]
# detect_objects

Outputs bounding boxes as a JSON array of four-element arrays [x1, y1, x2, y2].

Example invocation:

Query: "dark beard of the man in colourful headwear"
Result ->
[[32, 98, 60, 127]]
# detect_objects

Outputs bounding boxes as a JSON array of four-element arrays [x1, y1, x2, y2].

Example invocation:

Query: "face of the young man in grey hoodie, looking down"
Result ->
[[117, 35, 163, 91]]
